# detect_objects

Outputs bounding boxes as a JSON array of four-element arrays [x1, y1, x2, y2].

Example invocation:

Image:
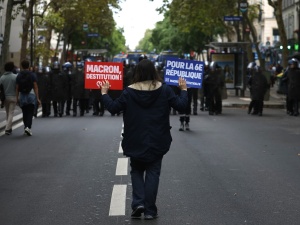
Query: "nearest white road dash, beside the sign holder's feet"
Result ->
[[109, 185, 127, 216]]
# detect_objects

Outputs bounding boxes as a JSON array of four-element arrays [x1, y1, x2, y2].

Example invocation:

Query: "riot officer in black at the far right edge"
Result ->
[[287, 58, 300, 116]]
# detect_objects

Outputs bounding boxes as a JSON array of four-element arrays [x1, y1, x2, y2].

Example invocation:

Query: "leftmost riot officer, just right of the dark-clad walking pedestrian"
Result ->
[[37, 67, 51, 117]]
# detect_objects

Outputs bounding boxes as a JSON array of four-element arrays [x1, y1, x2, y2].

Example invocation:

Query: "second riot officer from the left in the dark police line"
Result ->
[[50, 61, 69, 117]]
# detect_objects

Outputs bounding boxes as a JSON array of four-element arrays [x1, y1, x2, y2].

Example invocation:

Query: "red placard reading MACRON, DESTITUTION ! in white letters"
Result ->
[[84, 62, 124, 90]]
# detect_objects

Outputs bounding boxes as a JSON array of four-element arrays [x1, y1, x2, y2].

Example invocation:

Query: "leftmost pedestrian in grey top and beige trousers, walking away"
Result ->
[[0, 62, 17, 135]]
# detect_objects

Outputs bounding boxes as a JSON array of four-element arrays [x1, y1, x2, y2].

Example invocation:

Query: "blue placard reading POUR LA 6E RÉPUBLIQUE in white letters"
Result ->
[[164, 58, 204, 88]]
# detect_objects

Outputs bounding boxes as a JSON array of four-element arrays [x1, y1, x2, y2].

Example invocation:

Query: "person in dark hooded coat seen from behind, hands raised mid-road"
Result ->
[[101, 59, 188, 220]]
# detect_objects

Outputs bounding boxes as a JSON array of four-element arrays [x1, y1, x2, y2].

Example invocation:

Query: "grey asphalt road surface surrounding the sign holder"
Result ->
[[0, 108, 300, 225]]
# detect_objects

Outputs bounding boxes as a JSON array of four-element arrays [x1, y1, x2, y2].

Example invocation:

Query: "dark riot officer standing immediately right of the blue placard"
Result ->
[[205, 61, 224, 115]]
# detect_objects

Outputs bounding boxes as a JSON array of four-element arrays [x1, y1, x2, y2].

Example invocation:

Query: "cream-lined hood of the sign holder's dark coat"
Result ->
[[127, 81, 162, 108]]
